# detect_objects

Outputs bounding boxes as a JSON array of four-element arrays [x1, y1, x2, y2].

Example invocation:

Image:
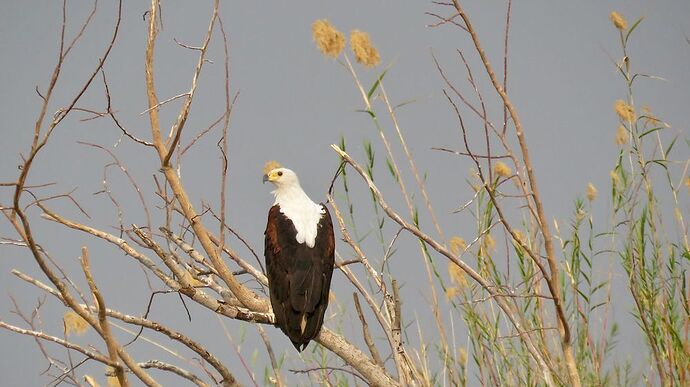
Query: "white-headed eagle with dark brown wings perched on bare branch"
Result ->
[[264, 167, 335, 352]]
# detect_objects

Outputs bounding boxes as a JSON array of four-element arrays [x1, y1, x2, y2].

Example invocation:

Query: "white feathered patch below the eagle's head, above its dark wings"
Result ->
[[274, 189, 325, 247]]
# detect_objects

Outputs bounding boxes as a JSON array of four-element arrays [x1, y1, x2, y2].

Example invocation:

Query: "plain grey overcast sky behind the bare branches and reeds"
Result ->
[[0, 0, 690, 385]]
